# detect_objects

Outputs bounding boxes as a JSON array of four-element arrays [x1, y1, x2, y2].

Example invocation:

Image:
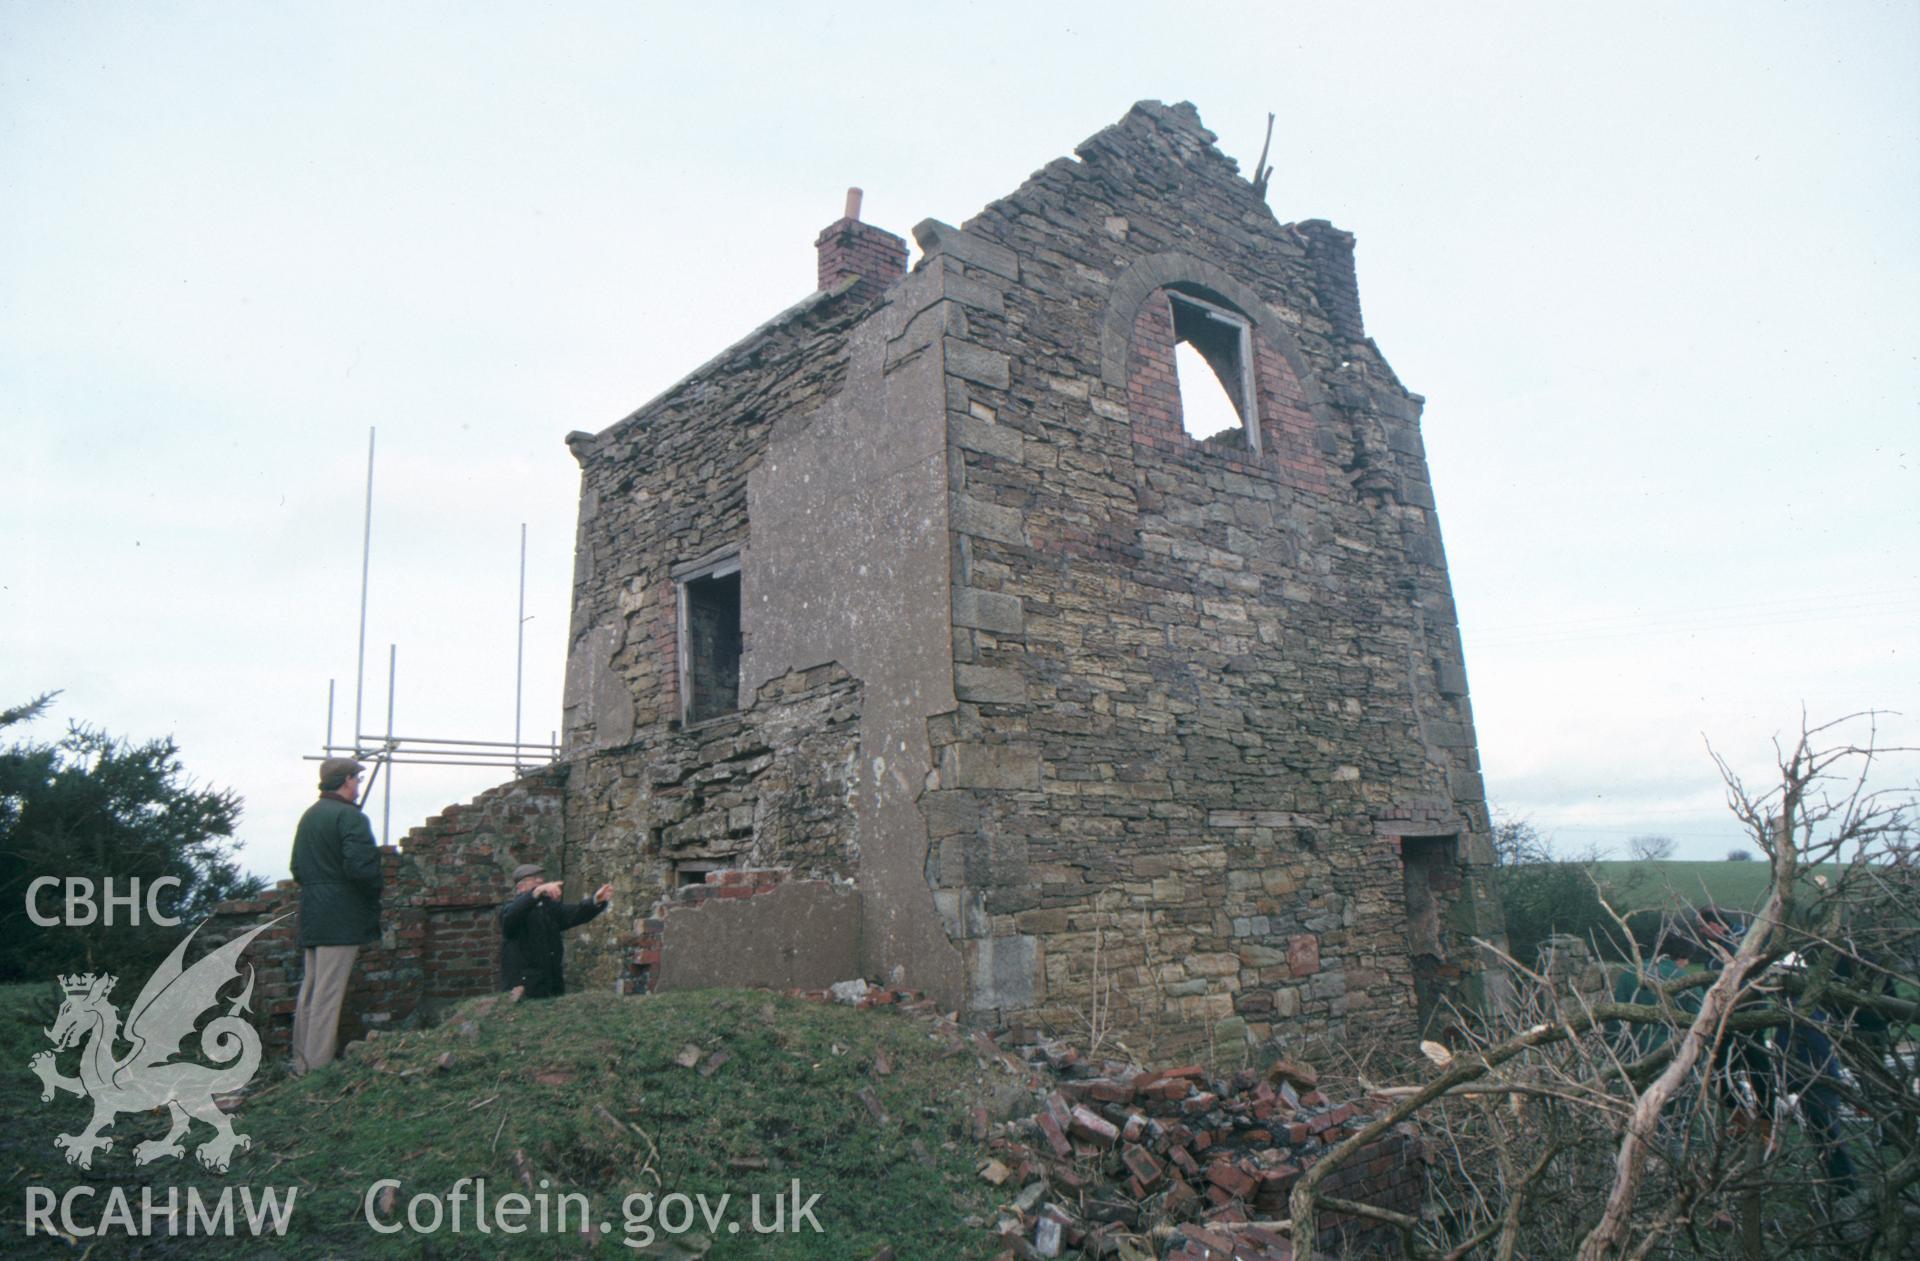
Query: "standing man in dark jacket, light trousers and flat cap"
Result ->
[[294, 758, 380, 1075]]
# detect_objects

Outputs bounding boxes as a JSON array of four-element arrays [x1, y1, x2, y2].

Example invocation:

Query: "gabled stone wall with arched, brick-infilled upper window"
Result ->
[[916, 102, 1498, 1046]]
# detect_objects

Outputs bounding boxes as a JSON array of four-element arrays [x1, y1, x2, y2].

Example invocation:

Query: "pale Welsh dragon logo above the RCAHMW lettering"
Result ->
[[27, 919, 278, 1173]]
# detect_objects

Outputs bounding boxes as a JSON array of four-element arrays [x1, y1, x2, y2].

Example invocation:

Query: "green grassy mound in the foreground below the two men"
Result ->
[[0, 987, 995, 1261]]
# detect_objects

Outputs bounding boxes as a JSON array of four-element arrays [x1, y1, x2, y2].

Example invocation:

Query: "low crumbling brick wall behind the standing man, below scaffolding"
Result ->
[[202, 768, 566, 1056]]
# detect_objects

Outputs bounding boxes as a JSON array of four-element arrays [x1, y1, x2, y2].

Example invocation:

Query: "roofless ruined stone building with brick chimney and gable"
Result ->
[[563, 102, 1500, 1040]]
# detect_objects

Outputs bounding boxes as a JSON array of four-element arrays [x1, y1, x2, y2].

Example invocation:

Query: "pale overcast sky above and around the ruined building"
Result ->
[[0, 0, 1920, 875]]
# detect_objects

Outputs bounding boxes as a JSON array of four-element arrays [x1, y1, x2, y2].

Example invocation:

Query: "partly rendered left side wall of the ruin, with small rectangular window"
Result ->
[[566, 221, 975, 1002]]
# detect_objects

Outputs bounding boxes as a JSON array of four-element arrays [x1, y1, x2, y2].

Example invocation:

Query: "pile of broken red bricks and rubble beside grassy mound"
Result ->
[[975, 1029, 1427, 1261]]
